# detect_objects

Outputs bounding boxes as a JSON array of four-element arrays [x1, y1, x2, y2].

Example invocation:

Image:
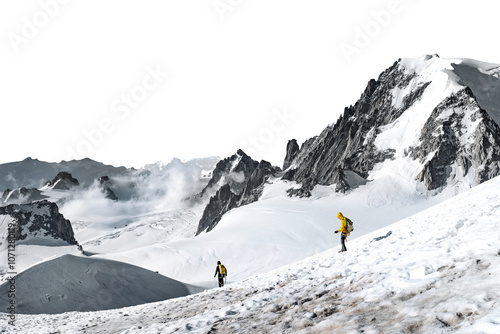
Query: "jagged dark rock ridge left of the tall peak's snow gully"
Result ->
[[283, 58, 430, 195]]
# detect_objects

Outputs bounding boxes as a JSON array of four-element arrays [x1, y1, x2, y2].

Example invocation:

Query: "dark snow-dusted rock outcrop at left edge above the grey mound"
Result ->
[[0, 200, 77, 245]]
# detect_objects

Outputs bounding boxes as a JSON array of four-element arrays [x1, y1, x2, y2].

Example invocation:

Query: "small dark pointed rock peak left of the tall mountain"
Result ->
[[196, 150, 280, 235]]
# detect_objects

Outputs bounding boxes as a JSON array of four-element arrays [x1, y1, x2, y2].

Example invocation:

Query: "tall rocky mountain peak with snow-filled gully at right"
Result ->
[[283, 55, 500, 195]]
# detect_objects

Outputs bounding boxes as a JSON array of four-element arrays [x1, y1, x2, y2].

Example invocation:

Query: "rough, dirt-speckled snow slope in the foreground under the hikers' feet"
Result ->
[[4, 177, 500, 334]]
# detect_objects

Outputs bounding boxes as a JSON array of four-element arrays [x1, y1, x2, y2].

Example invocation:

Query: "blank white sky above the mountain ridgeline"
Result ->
[[0, 0, 500, 167]]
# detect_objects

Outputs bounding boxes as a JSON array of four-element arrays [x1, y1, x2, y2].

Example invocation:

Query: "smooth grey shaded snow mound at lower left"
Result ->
[[0, 255, 193, 314]]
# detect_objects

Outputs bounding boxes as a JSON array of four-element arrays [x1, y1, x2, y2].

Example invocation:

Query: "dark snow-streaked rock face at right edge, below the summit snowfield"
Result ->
[[409, 88, 500, 190]]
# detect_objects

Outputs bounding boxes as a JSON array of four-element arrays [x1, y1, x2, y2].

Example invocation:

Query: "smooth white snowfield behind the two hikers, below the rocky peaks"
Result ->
[[88, 172, 445, 287]]
